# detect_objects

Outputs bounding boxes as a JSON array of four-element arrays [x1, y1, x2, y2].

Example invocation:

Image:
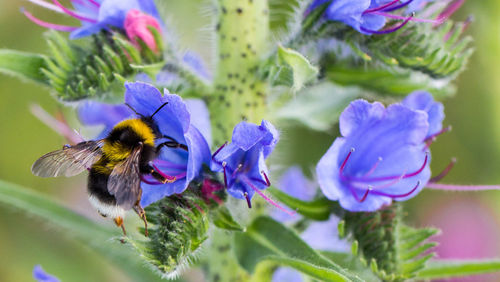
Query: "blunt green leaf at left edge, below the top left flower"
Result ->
[[0, 49, 47, 84]]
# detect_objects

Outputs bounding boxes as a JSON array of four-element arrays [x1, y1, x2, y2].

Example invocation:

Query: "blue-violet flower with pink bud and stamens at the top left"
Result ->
[[22, 0, 162, 40]]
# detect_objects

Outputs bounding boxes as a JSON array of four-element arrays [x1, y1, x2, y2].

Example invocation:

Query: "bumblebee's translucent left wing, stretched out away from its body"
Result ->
[[31, 140, 104, 177]]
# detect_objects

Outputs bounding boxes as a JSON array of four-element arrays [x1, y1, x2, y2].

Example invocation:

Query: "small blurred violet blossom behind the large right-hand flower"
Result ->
[[401, 91, 444, 139]]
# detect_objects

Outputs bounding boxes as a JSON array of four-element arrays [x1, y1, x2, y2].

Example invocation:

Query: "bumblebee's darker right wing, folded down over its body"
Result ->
[[107, 146, 142, 210]]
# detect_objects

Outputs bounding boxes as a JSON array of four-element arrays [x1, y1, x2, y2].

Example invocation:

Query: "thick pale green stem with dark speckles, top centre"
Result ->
[[209, 0, 270, 146]]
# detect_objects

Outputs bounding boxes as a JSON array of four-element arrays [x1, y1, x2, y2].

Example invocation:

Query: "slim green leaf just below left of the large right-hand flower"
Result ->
[[267, 187, 336, 220]]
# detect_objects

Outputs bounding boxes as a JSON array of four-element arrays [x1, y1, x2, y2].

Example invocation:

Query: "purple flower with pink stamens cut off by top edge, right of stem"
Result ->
[[309, 0, 442, 34]]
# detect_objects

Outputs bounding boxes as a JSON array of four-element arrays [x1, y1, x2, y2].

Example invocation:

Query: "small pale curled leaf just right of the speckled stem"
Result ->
[[278, 46, 319, 92]]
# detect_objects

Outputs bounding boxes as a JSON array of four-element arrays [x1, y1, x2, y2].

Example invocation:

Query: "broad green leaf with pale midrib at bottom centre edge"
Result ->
[[234, 216, 362, 281]]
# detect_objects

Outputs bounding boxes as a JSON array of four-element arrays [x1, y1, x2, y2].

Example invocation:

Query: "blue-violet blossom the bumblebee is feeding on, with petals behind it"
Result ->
[[78, 82, 210, 206]]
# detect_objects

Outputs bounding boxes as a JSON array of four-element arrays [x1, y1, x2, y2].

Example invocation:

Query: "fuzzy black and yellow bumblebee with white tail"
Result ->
[[31, 102, 188, 236]]
